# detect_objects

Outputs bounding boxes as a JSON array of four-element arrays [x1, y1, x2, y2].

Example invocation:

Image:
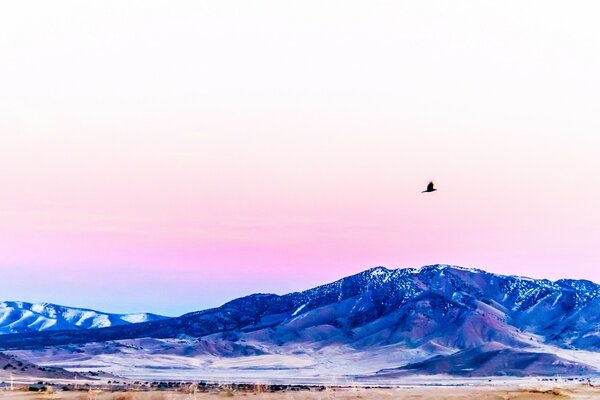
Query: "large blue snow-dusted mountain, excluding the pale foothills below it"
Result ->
[[0, 265, 600, 349]]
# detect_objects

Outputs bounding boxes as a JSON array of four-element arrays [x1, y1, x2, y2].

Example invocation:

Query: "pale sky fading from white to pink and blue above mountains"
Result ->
[[0, 0, 600, 315]]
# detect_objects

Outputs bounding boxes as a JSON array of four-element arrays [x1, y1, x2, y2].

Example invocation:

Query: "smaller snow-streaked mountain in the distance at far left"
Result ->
[[0, 301, 165, 334]]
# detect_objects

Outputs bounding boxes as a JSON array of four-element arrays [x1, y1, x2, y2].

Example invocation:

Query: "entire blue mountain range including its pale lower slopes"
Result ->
[[0, 265, 600, 379]]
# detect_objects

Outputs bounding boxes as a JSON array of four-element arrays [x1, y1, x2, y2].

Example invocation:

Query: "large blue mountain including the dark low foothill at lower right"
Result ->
[[0, 265, 600, 374]]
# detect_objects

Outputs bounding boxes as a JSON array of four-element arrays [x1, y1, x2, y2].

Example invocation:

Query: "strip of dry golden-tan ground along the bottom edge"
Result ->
[[0, 385, 600, 400]]
